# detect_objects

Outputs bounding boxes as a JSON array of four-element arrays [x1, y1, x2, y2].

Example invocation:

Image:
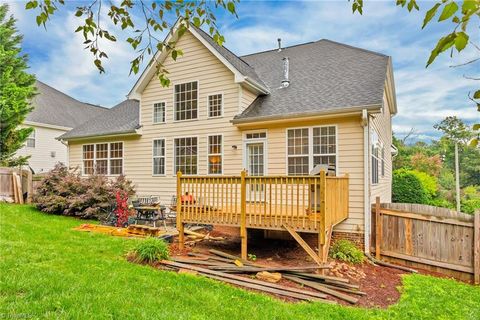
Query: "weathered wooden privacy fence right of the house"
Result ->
[[374, 198, 480, 283]]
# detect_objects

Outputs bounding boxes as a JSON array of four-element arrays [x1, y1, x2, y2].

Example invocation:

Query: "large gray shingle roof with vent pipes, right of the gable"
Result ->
[[234, 40, 389, 121]]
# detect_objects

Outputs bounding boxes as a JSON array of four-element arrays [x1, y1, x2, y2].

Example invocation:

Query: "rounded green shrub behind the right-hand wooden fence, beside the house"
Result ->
[[392, 169, 430, 204]]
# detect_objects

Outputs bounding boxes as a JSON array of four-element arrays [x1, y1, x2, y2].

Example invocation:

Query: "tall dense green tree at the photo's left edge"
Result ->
[[0, 4, 35, 166]]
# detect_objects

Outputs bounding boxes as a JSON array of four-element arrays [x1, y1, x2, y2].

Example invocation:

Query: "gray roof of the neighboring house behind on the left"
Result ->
[[26, 80, 108, 128]]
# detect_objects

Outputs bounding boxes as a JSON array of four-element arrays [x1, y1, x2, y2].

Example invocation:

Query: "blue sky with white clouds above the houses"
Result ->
[[7, 0, 480, 141]]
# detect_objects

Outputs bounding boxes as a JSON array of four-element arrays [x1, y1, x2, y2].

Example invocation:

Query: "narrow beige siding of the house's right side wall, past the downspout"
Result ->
[[370, 91, 392, 203]]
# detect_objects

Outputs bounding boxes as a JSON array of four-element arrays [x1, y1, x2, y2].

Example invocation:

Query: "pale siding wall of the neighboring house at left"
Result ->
[[17, 125, 67, 173]]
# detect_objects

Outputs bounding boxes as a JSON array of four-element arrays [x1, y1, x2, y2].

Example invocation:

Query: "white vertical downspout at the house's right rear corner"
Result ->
[[362, 109, 372, 254]]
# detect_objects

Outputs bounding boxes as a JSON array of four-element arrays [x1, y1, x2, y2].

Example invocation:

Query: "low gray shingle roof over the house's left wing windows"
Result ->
[[58, 100, 140, 140]]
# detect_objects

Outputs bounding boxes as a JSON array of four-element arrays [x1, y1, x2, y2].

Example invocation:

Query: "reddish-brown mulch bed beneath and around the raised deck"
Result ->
[[164, 227, 432, 308]]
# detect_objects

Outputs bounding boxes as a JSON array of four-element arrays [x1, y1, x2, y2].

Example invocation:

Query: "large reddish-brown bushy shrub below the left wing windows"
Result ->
[[33, 164, 135, 219]]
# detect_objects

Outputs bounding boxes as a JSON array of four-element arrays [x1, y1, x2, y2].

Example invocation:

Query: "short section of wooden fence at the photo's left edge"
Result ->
[[0, 168, 33, 203]]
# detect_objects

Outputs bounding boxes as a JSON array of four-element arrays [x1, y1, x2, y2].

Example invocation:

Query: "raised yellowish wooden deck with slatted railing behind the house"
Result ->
[[177, 172, 349, 264]]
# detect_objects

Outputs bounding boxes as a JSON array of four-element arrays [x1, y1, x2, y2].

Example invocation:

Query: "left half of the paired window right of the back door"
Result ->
[[287, 128, 309, 175]]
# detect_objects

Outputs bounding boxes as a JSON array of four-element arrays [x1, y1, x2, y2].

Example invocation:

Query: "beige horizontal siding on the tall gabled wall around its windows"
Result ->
[[70, 31, 248, 203]]
